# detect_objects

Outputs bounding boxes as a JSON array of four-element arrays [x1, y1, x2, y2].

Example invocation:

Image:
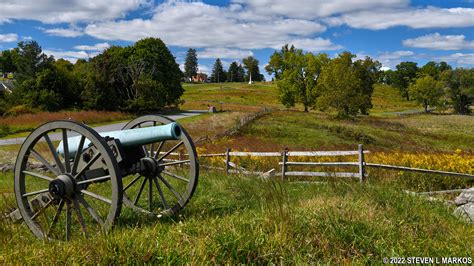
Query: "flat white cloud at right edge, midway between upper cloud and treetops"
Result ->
[[403, 33, 474, 50]]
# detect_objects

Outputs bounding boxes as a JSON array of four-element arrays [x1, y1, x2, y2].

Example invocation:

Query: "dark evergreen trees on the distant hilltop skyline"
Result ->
[[184, 48, 265, 83]]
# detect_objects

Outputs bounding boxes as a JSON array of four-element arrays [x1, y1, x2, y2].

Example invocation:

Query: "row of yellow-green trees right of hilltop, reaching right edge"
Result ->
[[265, 45, 474, 117]]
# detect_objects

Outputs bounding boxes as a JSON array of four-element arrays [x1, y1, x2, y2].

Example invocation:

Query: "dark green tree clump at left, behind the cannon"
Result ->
[[0, 38, 184, 114]]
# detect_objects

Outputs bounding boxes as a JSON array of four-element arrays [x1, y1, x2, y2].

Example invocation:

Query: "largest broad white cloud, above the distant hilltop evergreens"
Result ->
[[85, 1, 338, 50]]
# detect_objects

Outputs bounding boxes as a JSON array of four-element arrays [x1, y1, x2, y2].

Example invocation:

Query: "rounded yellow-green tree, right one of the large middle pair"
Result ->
[[316, 52, 380, 117]]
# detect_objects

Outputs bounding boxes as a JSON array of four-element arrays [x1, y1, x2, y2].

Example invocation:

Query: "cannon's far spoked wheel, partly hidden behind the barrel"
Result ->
[[123, 115, 199, 217]]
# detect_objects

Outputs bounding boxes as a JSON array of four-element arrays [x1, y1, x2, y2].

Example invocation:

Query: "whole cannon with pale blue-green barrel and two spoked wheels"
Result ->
[[14, 115, 199, 240]]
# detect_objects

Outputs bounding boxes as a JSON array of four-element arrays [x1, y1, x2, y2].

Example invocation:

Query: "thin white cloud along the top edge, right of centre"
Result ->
[[233, 0, 409, 19]]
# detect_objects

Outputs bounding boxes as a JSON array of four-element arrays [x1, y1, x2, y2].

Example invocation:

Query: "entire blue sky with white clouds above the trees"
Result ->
[[0, 0, 474, 79]]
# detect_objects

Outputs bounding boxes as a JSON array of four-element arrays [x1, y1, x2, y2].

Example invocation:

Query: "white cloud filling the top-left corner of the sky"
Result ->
[[0, 0, 151, 23]]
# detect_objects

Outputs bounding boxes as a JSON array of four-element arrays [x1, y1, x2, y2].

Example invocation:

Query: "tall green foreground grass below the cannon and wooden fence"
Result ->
[[0, 170, 474, 264]]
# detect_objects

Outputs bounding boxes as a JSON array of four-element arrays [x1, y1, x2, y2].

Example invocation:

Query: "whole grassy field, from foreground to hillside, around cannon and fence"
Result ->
[[0, 83, 474, 264]]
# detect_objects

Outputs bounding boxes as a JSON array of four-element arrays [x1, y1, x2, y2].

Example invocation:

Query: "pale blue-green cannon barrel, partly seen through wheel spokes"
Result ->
[[57, 122, 182, 157]]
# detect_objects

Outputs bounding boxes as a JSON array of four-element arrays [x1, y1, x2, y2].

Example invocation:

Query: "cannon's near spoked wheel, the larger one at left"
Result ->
[[15, 121, 123, 240]]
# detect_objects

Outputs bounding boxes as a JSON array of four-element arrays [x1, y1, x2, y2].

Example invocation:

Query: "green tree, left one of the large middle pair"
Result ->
[[275, 49, 329, 112]]
